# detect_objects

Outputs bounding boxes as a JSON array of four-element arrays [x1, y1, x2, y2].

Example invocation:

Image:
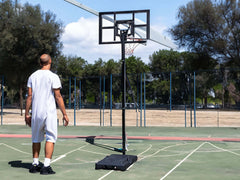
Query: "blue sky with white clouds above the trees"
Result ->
[[18, 0, 191, 64]]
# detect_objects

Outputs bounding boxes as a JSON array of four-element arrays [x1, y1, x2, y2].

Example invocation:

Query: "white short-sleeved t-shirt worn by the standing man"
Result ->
[[27, 70, 62, 120]]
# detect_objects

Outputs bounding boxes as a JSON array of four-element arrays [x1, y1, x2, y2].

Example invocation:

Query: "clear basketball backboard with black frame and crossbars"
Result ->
[[99, 10, 150, 44]]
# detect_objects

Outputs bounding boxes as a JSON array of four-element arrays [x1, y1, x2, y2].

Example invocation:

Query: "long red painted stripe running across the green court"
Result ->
[[0, 134, 240, 142]]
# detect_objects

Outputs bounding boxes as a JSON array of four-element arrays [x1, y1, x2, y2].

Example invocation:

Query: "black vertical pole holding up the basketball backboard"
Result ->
[[120, 30, 127, 155]]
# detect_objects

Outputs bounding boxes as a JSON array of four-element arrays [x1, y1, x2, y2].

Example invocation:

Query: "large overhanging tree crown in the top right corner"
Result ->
[[170, 0, 240, 67]]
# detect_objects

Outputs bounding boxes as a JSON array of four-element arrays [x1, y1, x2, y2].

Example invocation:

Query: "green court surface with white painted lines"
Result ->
[[0, 126, 240, 180]]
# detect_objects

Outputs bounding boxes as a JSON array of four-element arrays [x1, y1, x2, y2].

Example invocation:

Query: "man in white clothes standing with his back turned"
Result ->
[[25, 54, 69, 175]]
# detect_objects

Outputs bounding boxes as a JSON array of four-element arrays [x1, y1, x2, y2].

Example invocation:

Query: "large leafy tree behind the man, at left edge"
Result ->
[[0, 0, 62, 112]]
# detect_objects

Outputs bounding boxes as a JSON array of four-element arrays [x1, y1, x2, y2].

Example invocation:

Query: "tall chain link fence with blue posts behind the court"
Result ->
[[1, 69, 240, 127]]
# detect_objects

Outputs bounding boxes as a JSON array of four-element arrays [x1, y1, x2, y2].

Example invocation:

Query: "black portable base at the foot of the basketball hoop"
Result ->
[[95, 154, 137, 171]]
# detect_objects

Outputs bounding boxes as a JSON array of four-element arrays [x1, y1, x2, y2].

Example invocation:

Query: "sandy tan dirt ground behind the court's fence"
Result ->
[[1, 109, 240, 127]]
